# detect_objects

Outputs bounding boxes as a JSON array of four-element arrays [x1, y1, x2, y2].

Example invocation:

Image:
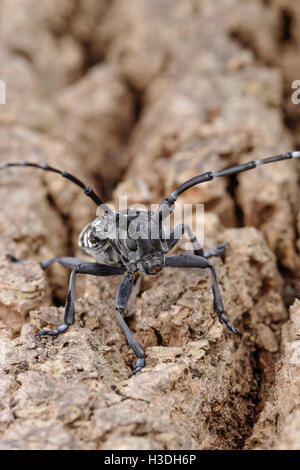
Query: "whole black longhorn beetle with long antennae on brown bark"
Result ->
[[0, 151, 300, 375]]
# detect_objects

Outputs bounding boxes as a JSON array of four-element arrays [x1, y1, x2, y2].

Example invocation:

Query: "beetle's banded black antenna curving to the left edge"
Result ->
[[0, 161, 111, 212]]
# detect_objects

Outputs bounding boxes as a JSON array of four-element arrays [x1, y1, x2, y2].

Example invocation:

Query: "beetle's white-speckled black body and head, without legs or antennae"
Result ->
[[78, 209, 167, 274]]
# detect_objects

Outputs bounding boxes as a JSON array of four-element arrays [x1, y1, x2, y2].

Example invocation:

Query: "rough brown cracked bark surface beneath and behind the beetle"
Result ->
[[0, 0, 300, 449]]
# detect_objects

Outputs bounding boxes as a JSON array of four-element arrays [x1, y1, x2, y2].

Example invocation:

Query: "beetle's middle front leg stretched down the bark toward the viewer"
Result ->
[[116, 273, 146, 377]]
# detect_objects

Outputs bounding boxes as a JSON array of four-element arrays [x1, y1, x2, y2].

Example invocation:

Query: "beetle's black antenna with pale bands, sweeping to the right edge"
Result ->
[[155, 151, 300, 221]]
